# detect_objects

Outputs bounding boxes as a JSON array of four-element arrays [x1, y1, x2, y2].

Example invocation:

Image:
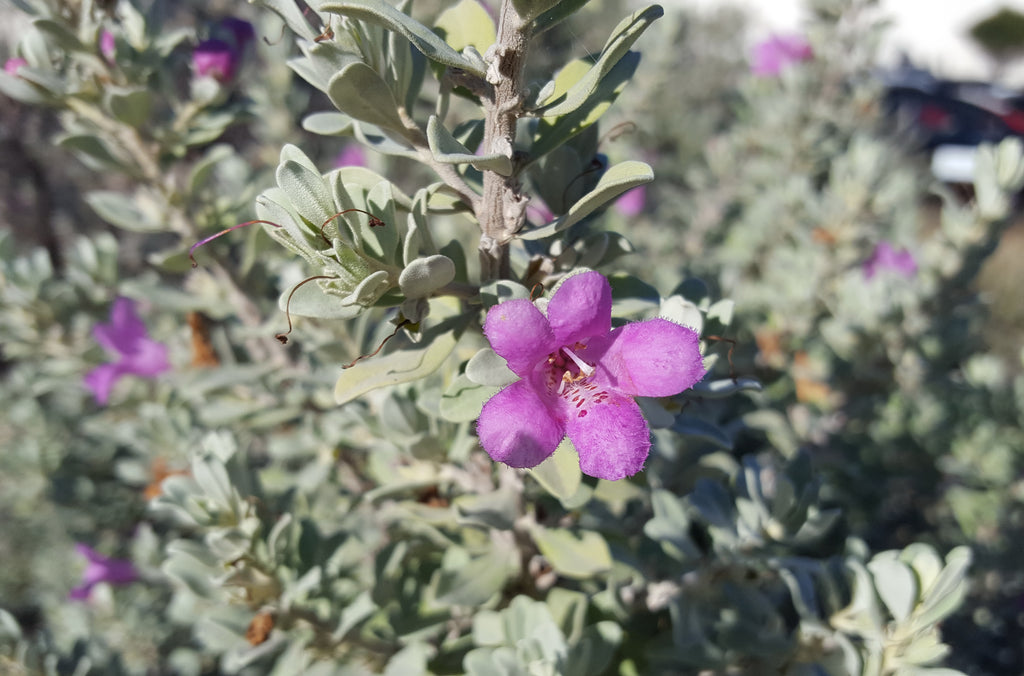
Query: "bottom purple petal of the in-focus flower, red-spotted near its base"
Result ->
[[566, 396, 650, 481]]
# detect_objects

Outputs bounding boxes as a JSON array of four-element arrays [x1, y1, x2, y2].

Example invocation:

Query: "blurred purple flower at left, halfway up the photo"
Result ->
[[84, 298, 171, 405]]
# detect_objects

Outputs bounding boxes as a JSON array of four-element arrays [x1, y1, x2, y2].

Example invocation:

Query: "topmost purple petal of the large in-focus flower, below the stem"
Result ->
[[548, 271, 611, 345]]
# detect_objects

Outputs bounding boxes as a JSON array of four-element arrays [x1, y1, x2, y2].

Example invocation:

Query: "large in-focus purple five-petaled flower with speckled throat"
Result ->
[[476, 271, 705, 479]]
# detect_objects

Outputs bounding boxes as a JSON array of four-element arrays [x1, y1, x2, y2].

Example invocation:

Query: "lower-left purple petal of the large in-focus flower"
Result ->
[[476, 381, 565, 467]]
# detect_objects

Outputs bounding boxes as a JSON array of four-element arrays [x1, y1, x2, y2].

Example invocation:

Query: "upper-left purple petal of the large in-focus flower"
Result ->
[[483, 298, 557, 378]]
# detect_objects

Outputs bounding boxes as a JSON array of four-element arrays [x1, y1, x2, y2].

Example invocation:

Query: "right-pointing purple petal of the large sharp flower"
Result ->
[[587, 318, 706, 396]]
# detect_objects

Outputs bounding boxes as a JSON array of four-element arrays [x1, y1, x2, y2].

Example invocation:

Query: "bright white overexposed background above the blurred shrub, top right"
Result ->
[[664, 0, 1024, 86]]
